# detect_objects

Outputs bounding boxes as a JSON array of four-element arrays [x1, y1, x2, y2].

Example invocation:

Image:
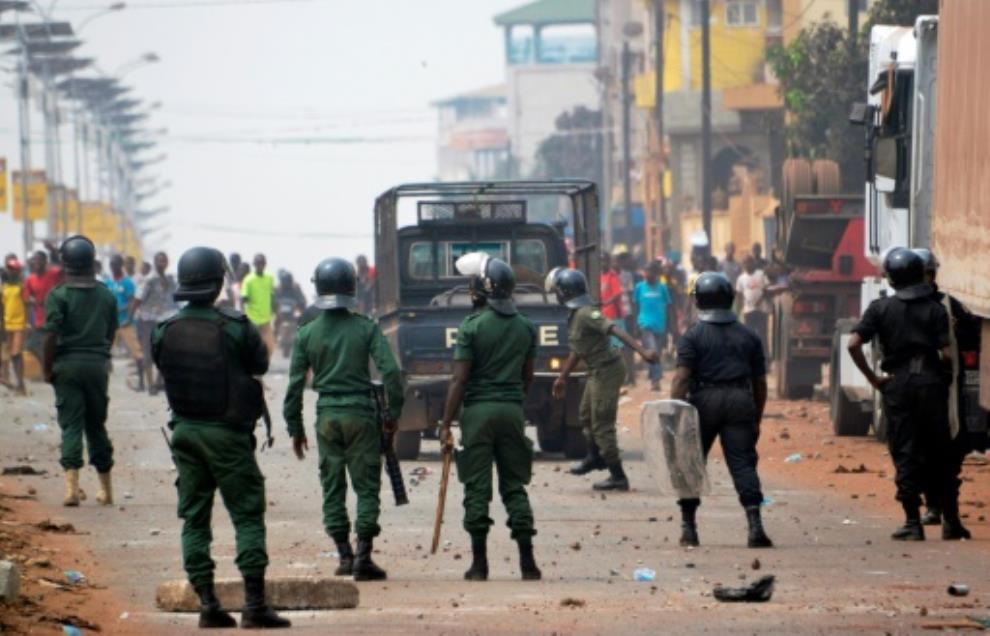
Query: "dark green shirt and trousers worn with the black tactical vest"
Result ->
[[151, 305, 268, 587]]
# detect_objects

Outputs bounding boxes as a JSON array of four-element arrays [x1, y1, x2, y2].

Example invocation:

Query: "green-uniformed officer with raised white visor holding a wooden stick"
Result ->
[[440, 252, 542, 581]]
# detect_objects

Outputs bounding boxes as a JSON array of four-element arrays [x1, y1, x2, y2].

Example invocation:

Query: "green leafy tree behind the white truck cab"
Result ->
[[767, 0, 938, 192]]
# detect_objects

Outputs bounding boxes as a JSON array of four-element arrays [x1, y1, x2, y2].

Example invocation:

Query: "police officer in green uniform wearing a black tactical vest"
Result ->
[[152, 247, 290, 629]]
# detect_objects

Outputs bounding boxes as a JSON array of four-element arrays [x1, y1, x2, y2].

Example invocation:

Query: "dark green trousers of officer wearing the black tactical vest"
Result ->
[[172, 422, 268, 586]]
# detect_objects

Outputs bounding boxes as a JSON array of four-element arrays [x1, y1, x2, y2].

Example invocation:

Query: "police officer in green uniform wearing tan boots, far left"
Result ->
[[42, 236, 117, 506]]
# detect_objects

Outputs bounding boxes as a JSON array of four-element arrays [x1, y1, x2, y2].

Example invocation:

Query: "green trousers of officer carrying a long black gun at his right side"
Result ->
[[316, 408, 382, 543]]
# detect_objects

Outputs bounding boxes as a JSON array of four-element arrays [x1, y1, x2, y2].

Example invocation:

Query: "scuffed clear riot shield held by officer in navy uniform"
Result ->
[[640, 400, 711, 499]]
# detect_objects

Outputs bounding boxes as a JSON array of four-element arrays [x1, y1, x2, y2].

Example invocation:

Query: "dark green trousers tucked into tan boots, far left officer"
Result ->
[[53, 359, 113, 473]]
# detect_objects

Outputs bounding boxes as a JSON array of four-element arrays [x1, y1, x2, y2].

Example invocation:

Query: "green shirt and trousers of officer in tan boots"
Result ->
[[43, 282, 117, 473]]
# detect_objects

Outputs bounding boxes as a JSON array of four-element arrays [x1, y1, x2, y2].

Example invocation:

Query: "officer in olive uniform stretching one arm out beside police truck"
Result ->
[[546, 268, 660, 491]]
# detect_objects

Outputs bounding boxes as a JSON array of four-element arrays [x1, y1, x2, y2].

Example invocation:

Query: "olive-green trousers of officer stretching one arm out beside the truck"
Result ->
[[578, 357, 626, 464]]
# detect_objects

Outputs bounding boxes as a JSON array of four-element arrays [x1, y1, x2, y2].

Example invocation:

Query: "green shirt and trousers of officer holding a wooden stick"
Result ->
[[454, 308, 536, 540]]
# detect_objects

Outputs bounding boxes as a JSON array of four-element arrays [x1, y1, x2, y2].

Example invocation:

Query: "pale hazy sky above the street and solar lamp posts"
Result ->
[[0, 0, 525, 292]]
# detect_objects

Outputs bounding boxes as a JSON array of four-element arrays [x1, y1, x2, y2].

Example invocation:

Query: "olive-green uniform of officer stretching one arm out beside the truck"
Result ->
[[568, 306, 626, 465]]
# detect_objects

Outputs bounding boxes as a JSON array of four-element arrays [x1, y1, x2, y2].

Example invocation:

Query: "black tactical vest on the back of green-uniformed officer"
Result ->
[[158, 313, 264, 430]]
